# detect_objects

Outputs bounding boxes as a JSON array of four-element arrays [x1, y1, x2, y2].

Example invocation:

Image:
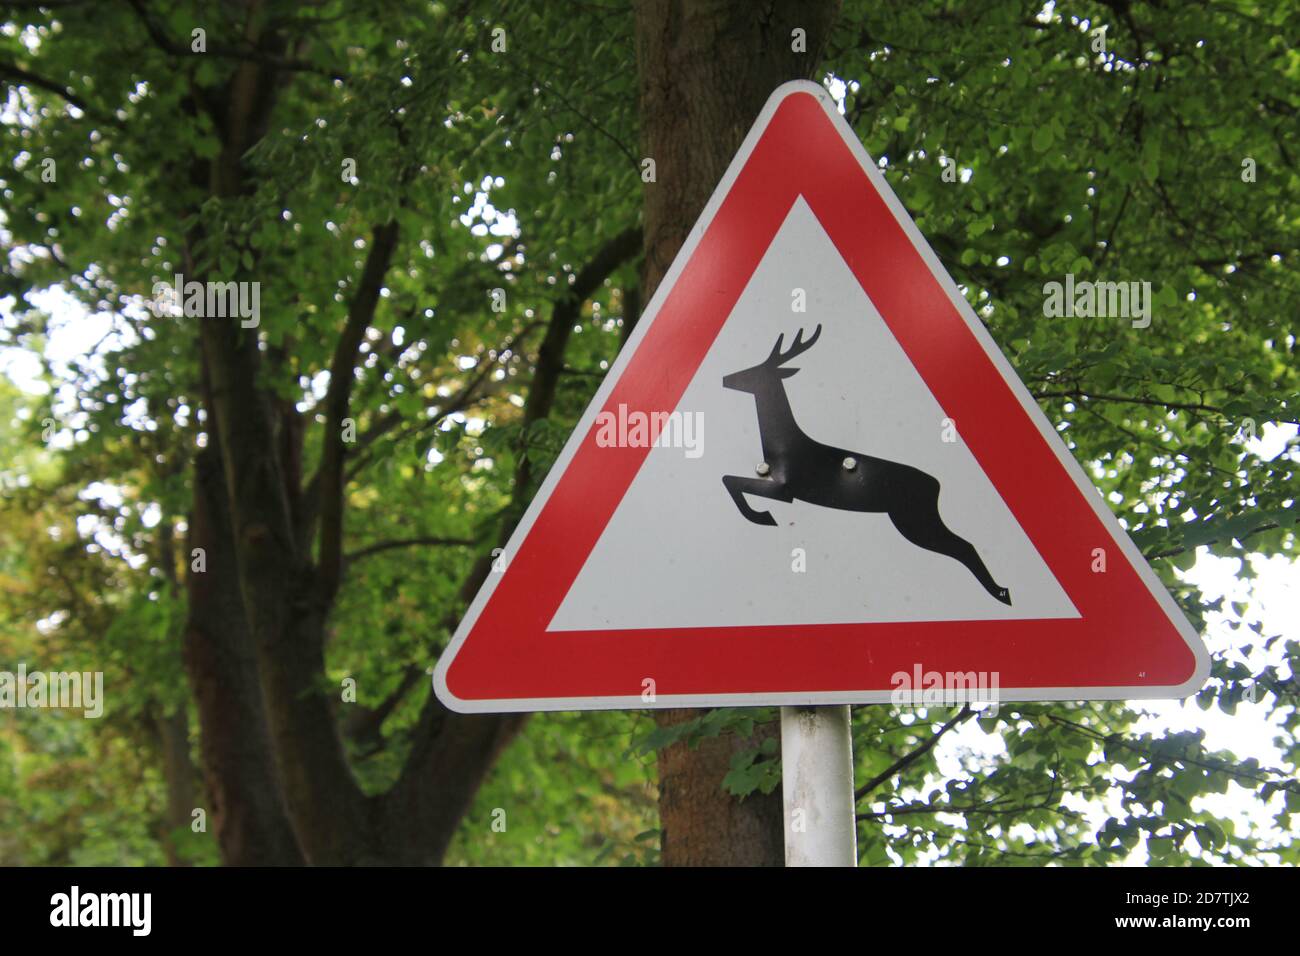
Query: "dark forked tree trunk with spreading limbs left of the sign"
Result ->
[[166, 13, 641, 865]]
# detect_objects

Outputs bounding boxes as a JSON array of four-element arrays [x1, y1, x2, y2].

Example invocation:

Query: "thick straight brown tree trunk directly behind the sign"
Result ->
[[637, 0, 840, 866]]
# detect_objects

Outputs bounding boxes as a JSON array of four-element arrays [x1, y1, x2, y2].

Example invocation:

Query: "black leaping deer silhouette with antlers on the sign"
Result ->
[[723, 325, 1011, 605]]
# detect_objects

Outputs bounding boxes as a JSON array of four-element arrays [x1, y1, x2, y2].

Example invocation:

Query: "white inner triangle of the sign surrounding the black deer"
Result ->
[[550, 199, 1078, 631]]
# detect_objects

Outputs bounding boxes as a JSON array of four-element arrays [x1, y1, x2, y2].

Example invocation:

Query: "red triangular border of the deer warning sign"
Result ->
[[434, 82, 1209, 711]]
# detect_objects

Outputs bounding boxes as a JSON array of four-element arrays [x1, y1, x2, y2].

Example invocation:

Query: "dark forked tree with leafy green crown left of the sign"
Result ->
[[5, 1, 640, 864]]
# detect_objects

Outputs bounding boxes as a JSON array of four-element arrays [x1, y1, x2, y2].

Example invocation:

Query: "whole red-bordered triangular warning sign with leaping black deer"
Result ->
[[434, 82, 1209, 711]]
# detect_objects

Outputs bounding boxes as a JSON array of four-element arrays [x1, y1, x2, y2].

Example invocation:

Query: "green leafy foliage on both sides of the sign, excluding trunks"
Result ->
[[0, 0, 1300, 865]]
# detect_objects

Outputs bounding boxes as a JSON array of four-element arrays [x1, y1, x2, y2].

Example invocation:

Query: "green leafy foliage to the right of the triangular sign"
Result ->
[[829, 4, 1300, 865]]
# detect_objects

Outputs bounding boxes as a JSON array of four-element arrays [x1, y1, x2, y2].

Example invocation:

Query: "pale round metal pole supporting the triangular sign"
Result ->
[[781, 704, 858, 866]]
